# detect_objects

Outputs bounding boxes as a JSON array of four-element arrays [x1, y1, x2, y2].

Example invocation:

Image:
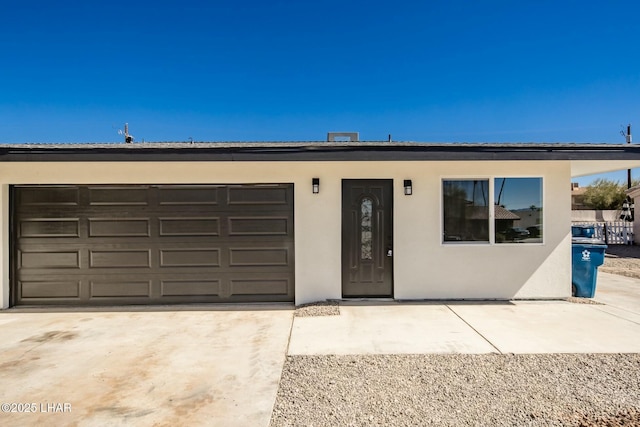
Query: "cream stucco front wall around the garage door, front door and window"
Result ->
[[0, 161, 571, 308]]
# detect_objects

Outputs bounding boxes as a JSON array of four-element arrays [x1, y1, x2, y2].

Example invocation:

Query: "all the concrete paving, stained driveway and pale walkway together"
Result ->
[[0, 273, 640, 426]]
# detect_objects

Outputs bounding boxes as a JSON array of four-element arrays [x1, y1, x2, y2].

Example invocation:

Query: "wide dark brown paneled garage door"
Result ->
[[12, 184, 294, 305]]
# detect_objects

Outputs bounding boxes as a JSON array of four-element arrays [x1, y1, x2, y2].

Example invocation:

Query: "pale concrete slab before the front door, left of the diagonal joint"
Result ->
[[289, 302, 496, 355]]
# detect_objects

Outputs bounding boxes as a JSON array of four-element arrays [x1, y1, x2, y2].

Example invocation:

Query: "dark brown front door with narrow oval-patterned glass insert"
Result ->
[[342, 179, 393, 297]]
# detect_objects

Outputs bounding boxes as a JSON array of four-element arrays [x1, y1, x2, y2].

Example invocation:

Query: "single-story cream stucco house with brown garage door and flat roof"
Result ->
[[0, 141, 640, 308]]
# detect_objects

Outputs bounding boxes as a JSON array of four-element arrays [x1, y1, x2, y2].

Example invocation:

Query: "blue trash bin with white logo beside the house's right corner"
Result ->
[[571, 237, 607, 298]]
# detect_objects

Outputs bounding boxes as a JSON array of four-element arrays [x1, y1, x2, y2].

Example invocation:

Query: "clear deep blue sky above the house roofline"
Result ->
[[0, 0, 640, 186]]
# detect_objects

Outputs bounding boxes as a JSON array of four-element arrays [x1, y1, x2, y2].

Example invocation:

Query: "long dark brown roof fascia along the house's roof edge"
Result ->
[[0, 143, 640, 162]]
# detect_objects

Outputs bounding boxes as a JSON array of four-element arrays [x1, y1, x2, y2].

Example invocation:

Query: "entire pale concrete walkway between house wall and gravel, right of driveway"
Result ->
[[289, 273, 640, 355]]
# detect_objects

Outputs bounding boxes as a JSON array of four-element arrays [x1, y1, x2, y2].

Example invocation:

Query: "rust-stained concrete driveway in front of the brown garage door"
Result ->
[[0, 306, 293, 426]]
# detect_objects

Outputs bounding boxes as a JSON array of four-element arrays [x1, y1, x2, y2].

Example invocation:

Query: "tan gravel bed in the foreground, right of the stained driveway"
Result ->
[[271, 354, 640, 427]]
